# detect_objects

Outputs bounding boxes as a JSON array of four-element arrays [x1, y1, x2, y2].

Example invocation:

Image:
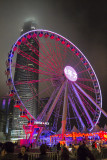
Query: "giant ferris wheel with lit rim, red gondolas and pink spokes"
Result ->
[[7, 29, 107, 136]]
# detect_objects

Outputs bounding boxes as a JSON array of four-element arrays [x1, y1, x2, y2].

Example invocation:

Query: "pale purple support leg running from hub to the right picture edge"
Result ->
[[75, 83, 107, 117]]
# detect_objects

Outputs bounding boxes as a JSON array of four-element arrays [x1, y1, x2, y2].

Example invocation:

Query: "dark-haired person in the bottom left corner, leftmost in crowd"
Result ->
[[0, 142, 17, 160]]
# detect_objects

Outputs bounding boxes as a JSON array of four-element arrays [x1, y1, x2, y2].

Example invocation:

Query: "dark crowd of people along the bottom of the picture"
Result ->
[[0, 141, 106, 160]]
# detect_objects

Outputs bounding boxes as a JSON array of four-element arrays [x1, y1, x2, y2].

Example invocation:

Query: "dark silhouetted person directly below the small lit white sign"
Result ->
[[36, 144, 50, 160]]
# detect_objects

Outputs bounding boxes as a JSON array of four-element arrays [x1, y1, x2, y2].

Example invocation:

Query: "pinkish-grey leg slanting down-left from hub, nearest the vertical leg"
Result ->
[[36, 82, 65, 141]]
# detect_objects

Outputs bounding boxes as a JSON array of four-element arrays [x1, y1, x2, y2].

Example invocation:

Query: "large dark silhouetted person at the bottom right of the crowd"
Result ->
[[77, 143, 95, 160]]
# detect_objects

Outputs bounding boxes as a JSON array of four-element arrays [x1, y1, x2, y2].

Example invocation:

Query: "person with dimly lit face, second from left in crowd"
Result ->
[[18, 146, 28, 160]]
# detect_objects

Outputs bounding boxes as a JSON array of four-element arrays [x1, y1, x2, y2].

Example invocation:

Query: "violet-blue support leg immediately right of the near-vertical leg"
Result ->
[[68, 96, 85, 128]]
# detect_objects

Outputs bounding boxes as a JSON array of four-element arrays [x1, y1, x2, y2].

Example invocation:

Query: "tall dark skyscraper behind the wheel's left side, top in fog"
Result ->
[[13, 21, 39, 139]]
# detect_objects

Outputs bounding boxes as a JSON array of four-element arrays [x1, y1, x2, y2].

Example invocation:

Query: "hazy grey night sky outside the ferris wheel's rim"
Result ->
[[0, 0, 107, 126]]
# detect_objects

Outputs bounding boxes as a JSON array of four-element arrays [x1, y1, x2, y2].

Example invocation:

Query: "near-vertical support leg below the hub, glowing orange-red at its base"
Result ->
[[62, 81, 68, 140]]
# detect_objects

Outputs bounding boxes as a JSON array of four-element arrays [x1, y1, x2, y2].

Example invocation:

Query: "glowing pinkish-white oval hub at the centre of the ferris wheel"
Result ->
[[64, 66, 77, 82]]
